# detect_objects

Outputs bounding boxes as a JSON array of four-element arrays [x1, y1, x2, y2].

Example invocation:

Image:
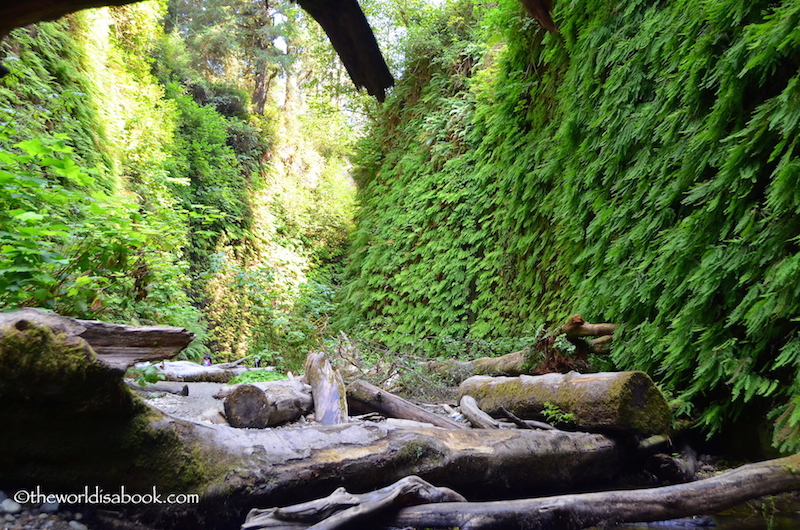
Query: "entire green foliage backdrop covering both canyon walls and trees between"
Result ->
[[0, 0, 800, 451]]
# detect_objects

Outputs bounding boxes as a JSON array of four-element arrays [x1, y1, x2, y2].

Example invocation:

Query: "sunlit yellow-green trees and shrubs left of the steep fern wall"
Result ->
[[0, 0, 353, 370]]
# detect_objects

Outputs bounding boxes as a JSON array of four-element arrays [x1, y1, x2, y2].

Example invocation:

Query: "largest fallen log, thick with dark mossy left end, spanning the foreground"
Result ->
[[0, 312, 625, 528]]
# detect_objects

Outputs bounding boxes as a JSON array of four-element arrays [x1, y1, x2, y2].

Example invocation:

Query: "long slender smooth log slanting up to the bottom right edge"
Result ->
[[382, 455, 800, 530]]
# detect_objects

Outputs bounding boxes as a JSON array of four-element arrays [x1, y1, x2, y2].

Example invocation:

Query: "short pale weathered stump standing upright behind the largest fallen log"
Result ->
[[305, 352, 347, 425]]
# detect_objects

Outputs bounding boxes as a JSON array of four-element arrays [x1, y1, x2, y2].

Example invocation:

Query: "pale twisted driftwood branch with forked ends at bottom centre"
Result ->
[[242, 475, 466, 530]]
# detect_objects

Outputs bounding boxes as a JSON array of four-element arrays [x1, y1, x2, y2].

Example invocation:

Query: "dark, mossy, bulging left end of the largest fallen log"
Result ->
[[0, 326, 210, 492]]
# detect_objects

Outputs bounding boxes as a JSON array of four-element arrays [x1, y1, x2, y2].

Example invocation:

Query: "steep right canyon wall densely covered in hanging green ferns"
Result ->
[[344, 0, 800, 450]]
